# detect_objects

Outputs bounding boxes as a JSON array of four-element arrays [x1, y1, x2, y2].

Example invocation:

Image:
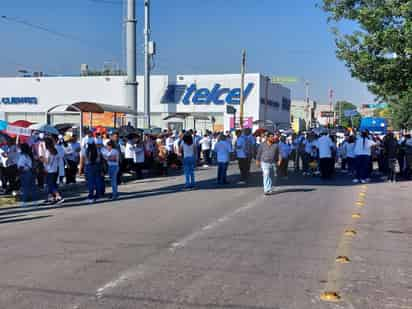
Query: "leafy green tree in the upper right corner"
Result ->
[[323, 0, 412, 126]]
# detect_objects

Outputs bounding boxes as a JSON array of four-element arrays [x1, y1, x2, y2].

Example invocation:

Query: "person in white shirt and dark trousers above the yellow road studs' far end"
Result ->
[[353, 131, 376, 183]]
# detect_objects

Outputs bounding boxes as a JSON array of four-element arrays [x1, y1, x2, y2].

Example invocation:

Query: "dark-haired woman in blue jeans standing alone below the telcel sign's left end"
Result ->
[[179, 134, 197, 189]]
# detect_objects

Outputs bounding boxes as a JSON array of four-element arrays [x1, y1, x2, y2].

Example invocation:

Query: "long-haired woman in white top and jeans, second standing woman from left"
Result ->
[[41, 138, 64, 204]]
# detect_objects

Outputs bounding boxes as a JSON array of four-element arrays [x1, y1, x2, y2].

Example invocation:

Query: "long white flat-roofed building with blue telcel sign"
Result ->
[[0, 74, 291, 131]]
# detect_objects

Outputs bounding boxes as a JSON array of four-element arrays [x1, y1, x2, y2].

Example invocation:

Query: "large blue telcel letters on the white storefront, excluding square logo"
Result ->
[[182, 83, 255, 105]]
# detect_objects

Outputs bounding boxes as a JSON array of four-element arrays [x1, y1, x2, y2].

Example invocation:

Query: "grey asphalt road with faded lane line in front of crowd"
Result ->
[[0, 168, 412, 309]]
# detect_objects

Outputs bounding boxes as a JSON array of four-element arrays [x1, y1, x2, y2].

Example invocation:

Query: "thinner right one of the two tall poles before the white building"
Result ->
[[144, 0, 153, 129]]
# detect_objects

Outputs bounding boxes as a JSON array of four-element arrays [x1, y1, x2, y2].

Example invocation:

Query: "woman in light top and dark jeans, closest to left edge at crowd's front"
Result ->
[[17, 144, 36, 207]]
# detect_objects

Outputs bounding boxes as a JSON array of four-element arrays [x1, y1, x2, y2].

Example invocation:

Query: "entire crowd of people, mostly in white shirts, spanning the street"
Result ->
[[0, 129, 412, 206]]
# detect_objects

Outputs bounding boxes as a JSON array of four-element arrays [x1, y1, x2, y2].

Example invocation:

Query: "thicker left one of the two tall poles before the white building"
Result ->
[[126, 0, 138, 128]]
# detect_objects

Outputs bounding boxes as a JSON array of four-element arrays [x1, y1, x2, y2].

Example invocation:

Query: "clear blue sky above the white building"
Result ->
[[0, 0, 374, 105]]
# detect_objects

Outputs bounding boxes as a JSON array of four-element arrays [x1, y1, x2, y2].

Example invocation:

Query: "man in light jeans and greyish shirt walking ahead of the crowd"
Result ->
[[256, 133, 281, 195]]
